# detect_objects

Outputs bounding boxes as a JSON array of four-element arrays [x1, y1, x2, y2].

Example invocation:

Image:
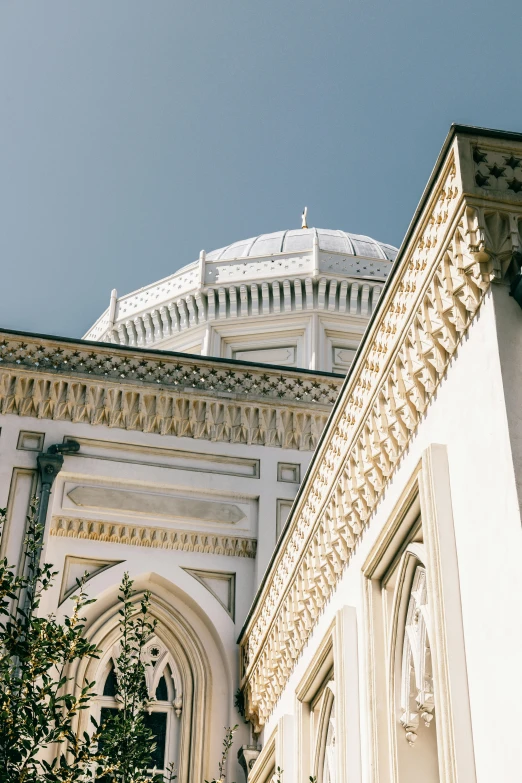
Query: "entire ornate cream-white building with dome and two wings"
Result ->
[[0, 126, 522, 783]]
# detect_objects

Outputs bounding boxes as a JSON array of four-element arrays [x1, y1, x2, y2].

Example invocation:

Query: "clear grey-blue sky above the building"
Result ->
[[0, 0, 522, 336]]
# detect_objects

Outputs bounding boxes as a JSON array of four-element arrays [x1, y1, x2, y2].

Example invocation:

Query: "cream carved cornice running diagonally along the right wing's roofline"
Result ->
[[240, 136, 522, 732]]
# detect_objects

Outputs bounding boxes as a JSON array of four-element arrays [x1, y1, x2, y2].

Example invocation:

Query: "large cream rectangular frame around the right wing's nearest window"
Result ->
[[362, 444, 476, 783]]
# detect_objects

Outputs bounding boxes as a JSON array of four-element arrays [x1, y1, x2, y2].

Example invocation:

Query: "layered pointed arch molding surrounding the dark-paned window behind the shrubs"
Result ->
[[70, 574, 228, 783]]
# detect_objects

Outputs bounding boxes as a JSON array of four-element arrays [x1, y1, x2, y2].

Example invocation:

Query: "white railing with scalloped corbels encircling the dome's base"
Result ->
[[85, 248, 391, 346]]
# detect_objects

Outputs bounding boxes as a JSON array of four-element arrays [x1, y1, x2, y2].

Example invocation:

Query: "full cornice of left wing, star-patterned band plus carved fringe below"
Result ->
[[0, 333, 343, 451]]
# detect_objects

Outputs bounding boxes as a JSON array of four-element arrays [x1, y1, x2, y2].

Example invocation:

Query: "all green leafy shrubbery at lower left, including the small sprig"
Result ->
[[0, 499, 237, 783]]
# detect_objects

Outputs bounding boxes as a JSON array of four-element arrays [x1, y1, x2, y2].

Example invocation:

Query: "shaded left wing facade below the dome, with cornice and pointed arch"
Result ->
[[0, 344, 343, 782]]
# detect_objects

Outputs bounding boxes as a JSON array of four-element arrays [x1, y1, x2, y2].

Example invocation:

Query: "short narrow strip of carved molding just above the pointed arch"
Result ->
[[51, 516, 257, 558]]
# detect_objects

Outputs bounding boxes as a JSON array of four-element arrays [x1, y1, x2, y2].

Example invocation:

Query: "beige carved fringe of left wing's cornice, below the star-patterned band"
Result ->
[[0, 368, 334, 451]]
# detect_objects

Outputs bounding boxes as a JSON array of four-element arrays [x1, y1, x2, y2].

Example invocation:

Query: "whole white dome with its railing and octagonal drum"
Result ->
[[85, 228, 397, 372]]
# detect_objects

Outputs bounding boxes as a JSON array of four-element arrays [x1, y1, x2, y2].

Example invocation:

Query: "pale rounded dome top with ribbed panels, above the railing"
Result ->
[[206, 228, 397, 261]]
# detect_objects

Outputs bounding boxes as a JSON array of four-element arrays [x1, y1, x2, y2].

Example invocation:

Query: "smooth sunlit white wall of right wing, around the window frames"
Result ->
[[264, 287, 522, 783]]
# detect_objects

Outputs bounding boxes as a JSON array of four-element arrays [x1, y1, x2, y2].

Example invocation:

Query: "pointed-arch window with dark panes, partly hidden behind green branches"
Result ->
[[95, 636, 183, 772]]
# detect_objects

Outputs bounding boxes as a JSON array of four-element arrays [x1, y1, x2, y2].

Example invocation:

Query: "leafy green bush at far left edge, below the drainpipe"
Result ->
[[0, 500, 101, 783]]
